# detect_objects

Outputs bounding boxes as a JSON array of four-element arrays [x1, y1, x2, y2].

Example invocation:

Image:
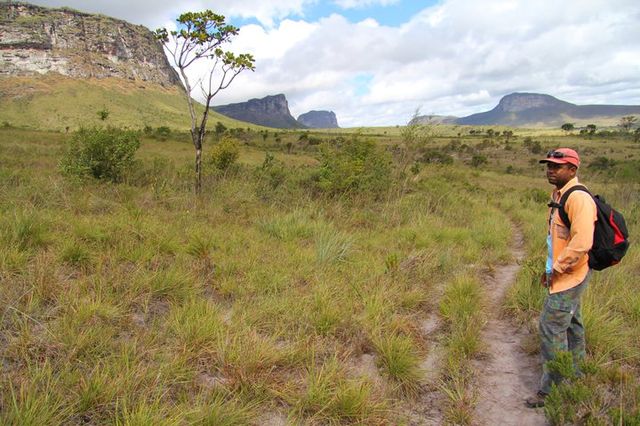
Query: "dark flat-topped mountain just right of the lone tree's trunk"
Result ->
[[212, 94, 305, 129]]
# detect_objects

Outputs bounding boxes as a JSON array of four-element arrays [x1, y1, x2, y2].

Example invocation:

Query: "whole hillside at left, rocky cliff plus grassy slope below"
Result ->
[[0, 3, 255, 130]]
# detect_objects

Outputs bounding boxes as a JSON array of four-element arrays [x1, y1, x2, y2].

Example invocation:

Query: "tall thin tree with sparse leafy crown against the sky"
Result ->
[[155, 10, 255, 194]]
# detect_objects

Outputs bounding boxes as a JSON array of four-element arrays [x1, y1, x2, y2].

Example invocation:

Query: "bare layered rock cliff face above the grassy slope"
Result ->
[[0, 3, 180, 86]]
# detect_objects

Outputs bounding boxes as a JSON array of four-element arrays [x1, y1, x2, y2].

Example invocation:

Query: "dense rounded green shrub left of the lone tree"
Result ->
[[60, 127, 140, 182]]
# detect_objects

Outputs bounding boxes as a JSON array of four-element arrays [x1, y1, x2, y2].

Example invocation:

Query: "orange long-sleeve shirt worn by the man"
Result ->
[[549, 177, 598, 293]]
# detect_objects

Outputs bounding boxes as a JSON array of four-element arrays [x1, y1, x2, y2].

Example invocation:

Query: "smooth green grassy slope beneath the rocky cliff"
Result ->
[[0, 73, 260, 131]]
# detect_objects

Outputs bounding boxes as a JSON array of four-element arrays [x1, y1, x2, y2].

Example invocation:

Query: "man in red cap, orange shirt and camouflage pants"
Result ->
[[526, 148, 597, 408]]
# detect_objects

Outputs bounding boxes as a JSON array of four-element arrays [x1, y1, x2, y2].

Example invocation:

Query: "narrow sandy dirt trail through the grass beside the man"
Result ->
[[474, 229, 547, 426]]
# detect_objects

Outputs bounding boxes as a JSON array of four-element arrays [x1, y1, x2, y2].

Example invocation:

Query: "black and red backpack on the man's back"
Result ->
[[549, 185, 629, 271]]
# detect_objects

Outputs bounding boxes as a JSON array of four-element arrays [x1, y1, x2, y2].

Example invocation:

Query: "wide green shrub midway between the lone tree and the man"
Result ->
[[314, 138, 391, 195]]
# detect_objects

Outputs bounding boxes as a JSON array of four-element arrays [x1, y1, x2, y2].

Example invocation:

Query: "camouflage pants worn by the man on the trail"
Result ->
[[539, 273, 591, 394]]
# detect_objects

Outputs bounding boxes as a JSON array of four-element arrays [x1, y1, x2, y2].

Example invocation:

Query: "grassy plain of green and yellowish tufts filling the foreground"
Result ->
[[0, 123, 640, 425]]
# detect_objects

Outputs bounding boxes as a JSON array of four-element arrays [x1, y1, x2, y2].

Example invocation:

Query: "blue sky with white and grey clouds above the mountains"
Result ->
[[31, 0, 640, 127]]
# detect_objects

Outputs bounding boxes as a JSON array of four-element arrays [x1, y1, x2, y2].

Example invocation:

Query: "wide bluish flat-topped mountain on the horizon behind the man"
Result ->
[[455, 93, 640, 127]]
